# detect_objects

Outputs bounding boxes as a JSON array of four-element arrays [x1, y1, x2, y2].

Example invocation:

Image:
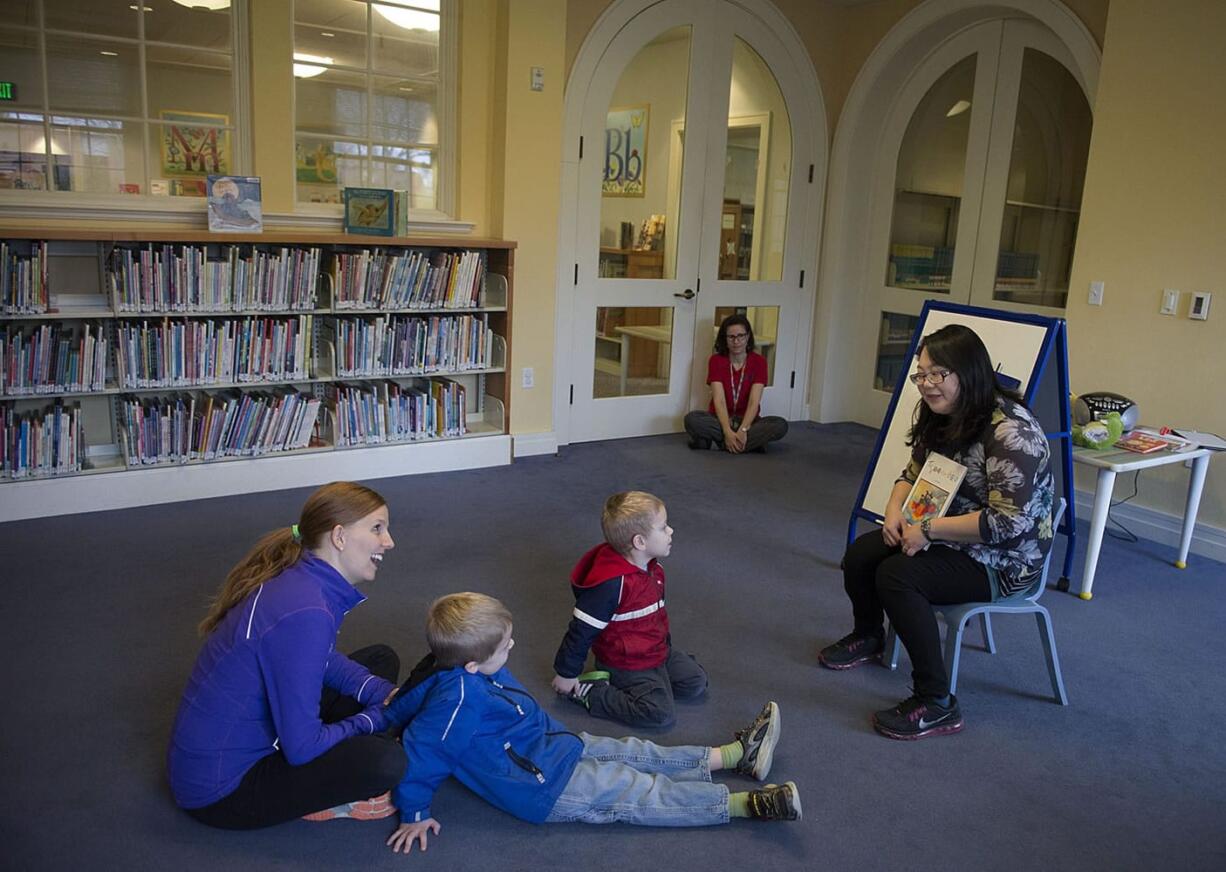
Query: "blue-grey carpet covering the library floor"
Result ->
[[0, 424, 1226, 872]]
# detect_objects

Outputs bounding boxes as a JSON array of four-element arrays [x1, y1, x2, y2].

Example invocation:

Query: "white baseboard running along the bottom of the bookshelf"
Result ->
[[0, 435, 511, 522]]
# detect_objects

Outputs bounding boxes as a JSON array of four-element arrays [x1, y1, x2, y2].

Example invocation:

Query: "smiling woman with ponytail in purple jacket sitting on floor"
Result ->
[[167, 482, 405, 829]]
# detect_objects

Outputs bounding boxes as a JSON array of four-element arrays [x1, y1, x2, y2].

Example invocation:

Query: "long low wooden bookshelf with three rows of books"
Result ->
[[0, 229, 515, 522]]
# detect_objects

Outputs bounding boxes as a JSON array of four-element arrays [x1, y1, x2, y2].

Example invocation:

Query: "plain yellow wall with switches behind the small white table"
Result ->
[[1068, 0, 1226, 529]]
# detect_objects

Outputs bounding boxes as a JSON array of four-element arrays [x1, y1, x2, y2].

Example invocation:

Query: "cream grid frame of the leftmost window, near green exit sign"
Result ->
[[0, 0, 253, 220]]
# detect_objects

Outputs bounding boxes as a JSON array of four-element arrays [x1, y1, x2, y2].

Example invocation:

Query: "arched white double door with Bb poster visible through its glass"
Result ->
[[559, 0, 824, 442]]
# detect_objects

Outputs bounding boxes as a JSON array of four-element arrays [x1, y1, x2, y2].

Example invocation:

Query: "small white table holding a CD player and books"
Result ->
[[1073, 448, 1213, 600]]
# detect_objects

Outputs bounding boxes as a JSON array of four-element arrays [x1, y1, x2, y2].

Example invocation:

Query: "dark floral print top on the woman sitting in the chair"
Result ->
[[899, 397, 1056, 597]]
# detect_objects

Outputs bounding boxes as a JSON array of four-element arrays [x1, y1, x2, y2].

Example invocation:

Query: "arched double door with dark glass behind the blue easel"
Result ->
[[856, 13, 1091, 421]]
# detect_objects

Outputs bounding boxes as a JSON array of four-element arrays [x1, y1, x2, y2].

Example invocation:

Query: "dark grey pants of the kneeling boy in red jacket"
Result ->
[[587, 648, 707, 727]]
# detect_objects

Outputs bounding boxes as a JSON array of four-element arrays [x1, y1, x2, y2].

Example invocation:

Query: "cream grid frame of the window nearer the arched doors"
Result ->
[[289, 0, 460, 224]]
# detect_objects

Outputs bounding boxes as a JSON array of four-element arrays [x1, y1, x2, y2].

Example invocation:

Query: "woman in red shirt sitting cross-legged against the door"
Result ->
[[685, 314, 787, 454]]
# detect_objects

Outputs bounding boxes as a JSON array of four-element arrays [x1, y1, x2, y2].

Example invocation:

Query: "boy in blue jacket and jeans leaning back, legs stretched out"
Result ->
[[385, 594, 801, 854]]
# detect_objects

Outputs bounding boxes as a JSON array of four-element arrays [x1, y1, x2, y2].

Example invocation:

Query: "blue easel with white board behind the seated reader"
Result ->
[[847, 300, 1076, 590]]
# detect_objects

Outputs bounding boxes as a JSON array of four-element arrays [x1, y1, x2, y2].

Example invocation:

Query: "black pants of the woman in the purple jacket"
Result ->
[[188, 645, 407, 829]]
